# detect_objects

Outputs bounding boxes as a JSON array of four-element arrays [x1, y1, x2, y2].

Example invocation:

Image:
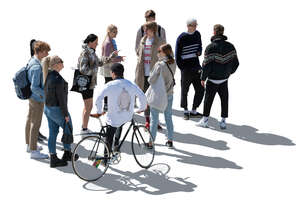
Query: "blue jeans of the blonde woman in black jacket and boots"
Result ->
[[44, 105, 73, 154]]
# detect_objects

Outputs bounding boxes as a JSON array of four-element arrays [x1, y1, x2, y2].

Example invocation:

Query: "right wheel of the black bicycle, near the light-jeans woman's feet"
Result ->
[[131, 125, 155, 169]]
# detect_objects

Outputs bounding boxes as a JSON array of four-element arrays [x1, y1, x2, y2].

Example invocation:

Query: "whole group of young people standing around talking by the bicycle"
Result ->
[[25, 10, 239, 167]]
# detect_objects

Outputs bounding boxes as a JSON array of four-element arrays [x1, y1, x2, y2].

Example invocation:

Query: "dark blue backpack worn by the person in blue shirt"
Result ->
[[13, 61, 32, 99]]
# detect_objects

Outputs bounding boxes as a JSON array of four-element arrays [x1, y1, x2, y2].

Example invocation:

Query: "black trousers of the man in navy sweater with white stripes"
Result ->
[[180, 70, 204, 110]]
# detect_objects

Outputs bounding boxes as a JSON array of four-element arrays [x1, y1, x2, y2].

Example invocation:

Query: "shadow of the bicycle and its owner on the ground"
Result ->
[[83, 163, 197, 195]]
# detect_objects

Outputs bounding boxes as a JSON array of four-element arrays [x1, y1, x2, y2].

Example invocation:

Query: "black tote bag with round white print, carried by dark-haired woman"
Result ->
[[71, 69, 92, 93]]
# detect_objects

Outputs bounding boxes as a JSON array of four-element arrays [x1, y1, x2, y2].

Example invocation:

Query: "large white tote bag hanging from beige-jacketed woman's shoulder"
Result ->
[[146, 73, 168, 112]]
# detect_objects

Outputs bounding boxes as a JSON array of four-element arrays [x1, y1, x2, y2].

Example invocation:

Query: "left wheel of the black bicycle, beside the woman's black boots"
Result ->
[[72, 135, 110, 181]]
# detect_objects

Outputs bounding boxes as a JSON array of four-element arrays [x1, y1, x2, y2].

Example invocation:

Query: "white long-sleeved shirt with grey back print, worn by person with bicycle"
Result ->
[[96, 79, 147, 127]]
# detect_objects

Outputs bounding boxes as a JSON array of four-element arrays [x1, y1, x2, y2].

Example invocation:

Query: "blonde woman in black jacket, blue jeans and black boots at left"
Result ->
[[43, 56, 78, 168]]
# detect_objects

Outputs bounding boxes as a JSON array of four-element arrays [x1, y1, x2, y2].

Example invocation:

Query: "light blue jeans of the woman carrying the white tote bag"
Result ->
[[150, 95, 174, 141]]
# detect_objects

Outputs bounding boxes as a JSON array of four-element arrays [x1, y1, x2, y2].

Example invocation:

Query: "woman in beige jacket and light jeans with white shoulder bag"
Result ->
[[147, 44, 176, 149]]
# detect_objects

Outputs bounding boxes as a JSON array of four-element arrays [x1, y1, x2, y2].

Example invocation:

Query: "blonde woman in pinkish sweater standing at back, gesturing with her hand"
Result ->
[[100, 24, 124, 111]]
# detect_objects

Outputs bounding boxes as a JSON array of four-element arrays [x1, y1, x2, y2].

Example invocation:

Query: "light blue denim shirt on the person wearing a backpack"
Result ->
[[28, 56, 45, 102]]
